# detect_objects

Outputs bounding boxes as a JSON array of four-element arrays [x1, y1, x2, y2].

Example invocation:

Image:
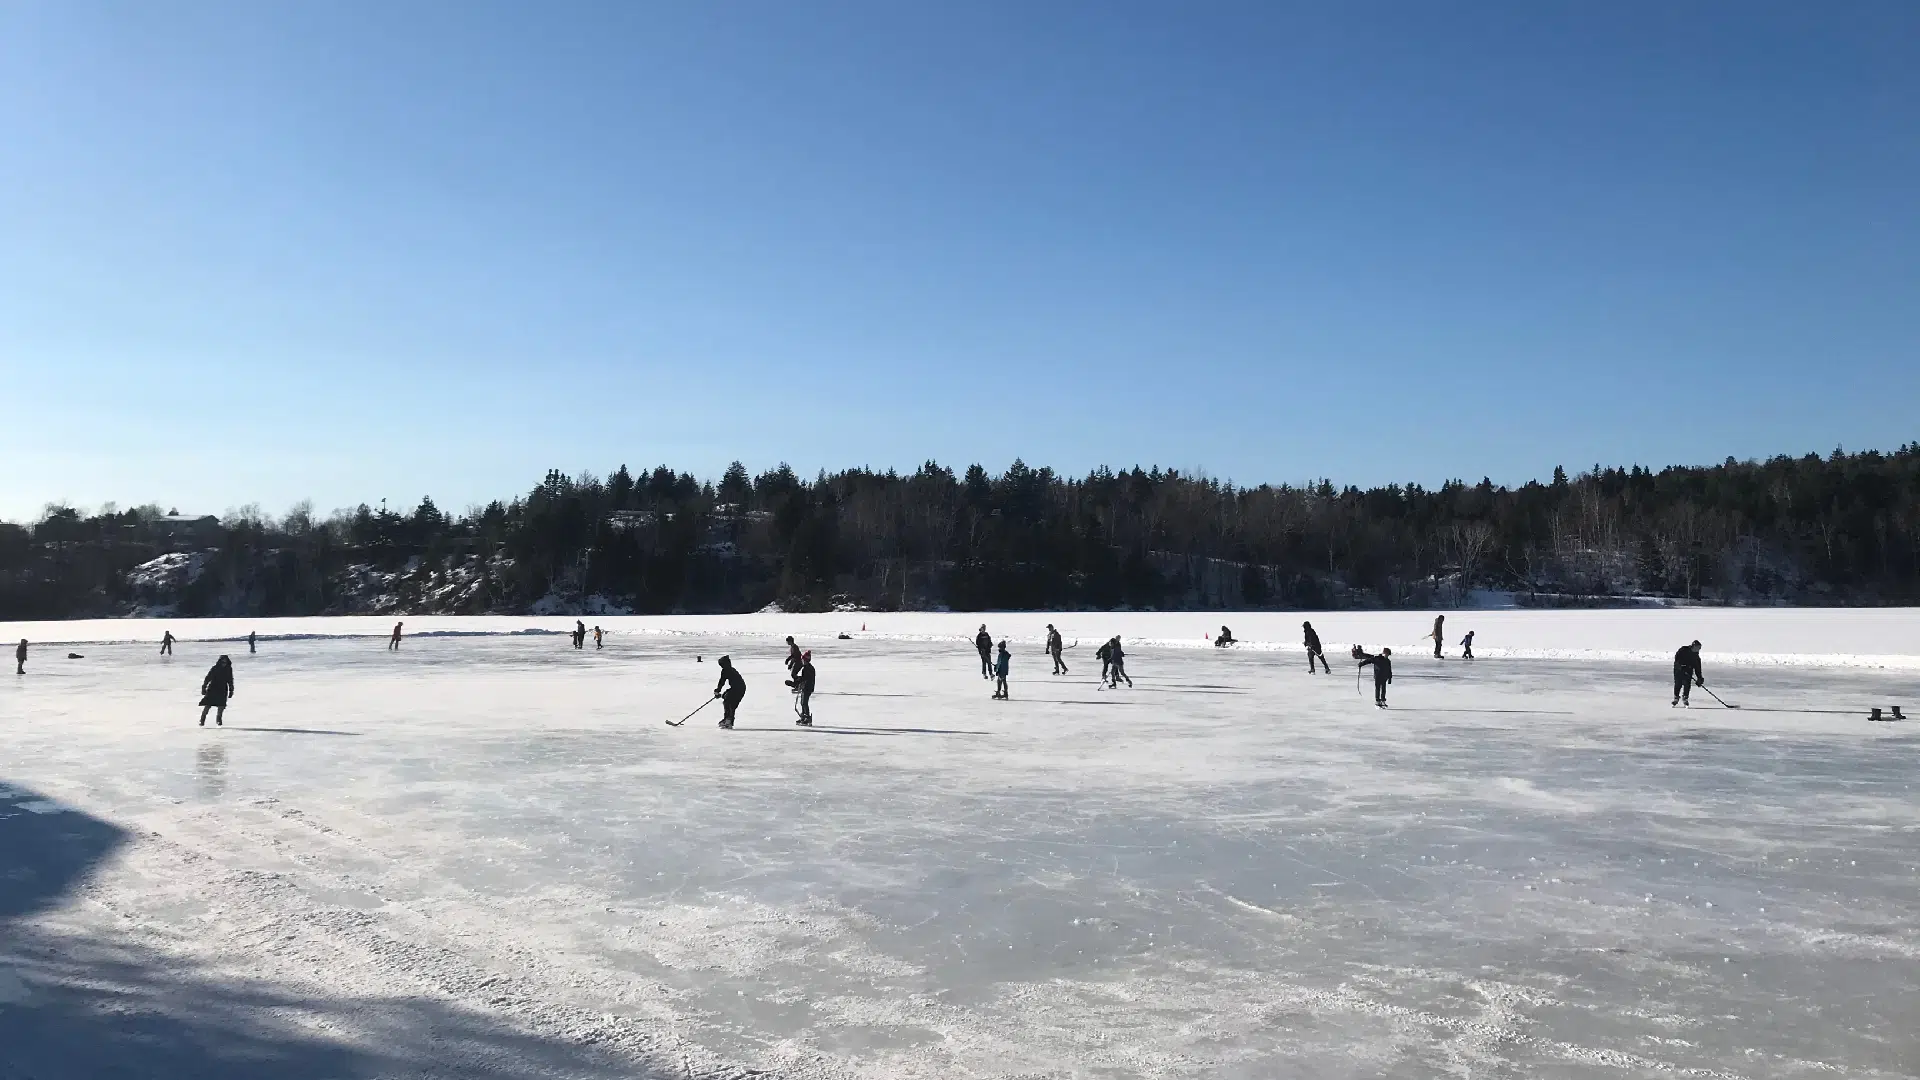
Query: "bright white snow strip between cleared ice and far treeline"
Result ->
[[0, 607, 1920, 669]]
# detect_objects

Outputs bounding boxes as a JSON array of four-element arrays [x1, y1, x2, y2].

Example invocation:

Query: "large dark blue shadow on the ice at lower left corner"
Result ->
[[0, 784, 678, 1080]]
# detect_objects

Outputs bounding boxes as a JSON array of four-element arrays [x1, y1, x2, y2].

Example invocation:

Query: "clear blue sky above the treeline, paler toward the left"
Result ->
[[0, 0, 1920, 519]]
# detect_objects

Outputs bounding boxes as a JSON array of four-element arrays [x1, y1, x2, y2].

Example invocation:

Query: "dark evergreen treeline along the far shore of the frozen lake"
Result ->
[[0, 444, 1920, 619]]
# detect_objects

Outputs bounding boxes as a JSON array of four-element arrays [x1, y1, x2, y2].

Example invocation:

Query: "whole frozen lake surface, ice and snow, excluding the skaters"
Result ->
[[0, 609, 1920, 1080]]
